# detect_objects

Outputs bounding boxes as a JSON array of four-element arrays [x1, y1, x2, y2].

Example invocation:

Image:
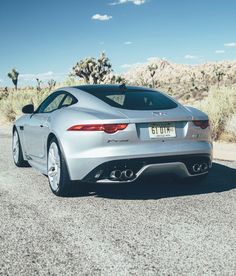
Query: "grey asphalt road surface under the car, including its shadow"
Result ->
[[0, 130, 236, 275]]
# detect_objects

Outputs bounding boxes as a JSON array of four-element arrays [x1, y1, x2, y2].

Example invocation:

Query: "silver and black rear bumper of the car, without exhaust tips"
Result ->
[[65, 141, 212, 182]]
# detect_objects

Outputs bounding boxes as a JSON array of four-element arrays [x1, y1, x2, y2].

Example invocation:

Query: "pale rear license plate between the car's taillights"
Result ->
[[149, 123, 176, 139]]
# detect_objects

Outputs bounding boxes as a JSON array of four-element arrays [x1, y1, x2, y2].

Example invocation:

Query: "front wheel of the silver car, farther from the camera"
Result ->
[[12, 128, 29, 167]]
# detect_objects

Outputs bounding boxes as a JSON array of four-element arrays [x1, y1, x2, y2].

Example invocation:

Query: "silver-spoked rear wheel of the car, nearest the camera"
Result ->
[[47, 138, 71, 196]]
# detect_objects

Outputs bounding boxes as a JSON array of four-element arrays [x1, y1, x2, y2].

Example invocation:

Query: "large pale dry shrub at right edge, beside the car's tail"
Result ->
[[195, 86, 236, 140]]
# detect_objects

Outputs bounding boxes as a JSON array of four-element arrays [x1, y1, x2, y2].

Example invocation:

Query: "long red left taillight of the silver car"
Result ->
[[67, 124, 128, 133]]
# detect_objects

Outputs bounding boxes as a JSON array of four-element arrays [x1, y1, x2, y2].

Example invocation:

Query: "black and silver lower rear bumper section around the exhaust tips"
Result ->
[[83, 154, 212, 183]]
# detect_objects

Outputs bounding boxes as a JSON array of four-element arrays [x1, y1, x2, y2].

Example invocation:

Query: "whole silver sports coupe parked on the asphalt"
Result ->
[[12, 85, 212, 195]]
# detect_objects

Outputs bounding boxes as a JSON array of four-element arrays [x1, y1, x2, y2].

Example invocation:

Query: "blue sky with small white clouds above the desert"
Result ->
[[0, 0, 236, 86]]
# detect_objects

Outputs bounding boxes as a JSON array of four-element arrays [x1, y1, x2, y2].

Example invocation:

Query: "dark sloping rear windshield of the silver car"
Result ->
[[79, 89, 177, 110]]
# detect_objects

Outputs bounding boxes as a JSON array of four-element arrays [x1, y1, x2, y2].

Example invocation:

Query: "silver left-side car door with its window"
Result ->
[[24, 92, 66, 161]]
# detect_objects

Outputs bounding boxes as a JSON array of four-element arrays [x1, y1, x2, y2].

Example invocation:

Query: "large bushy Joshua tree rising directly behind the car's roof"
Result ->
[[72, 53, 112, 84]]
